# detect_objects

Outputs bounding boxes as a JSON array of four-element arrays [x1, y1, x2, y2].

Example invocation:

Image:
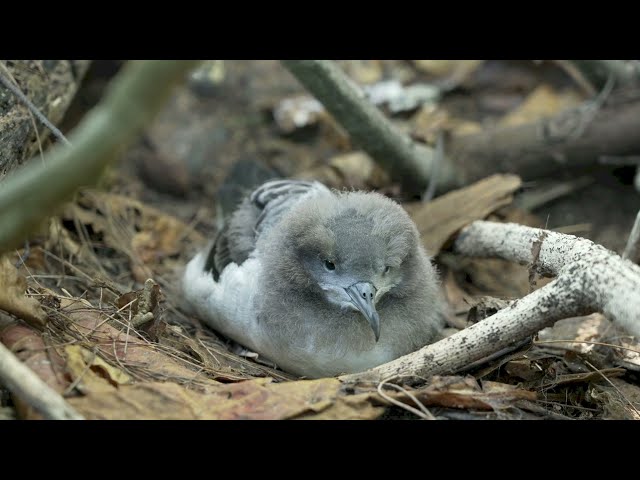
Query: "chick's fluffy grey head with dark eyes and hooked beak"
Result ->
[[272, 192, 419, 341]]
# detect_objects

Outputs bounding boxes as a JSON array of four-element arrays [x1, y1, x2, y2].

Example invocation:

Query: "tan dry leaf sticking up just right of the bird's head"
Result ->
[[404, 174, 522, 255]]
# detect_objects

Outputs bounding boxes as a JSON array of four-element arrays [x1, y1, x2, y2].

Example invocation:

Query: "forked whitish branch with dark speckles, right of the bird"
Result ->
[[341, 221, 640, 382]]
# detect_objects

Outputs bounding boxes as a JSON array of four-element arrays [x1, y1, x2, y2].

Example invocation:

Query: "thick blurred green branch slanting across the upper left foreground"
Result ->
[[0, 60, 197, 252]]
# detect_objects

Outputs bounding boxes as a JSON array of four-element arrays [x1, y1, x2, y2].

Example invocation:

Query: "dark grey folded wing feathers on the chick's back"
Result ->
[[204, 180, 330, 281]]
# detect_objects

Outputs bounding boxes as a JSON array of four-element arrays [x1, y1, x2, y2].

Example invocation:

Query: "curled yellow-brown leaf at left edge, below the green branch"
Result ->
[[0, 255, 47, 327]]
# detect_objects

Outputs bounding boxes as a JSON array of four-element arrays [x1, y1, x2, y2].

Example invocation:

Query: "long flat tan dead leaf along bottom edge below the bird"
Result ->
[[69, 378, 383, 420]]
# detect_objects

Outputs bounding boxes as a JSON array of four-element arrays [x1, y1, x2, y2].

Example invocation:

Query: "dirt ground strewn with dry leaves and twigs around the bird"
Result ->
[[0, 60, 640, 419]]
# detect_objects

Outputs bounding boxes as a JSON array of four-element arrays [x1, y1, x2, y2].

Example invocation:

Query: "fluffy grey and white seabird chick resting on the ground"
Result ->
[[182, 179, 446, 378]]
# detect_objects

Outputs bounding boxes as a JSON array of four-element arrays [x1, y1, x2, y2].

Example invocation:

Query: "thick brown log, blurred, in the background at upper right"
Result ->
[[446, 87, 640, 184]]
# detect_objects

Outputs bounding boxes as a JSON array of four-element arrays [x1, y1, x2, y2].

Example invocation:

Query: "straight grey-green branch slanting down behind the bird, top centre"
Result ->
[[282, 60, 455, 193]]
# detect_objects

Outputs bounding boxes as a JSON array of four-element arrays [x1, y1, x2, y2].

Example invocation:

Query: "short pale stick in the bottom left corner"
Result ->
[[0, 343, 83, 420]]
